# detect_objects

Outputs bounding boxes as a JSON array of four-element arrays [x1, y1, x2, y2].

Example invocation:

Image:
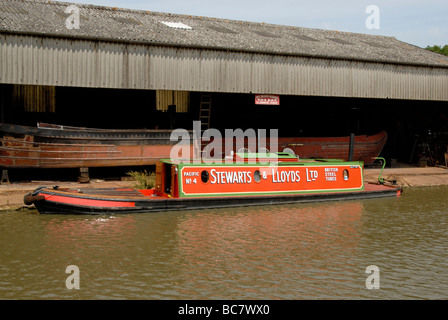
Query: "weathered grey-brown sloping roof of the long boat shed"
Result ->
[[0, 0, 448, 67]]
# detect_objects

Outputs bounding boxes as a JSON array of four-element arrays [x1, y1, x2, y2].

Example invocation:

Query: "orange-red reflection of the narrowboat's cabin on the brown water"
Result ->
[[177, 201, 364, 263]]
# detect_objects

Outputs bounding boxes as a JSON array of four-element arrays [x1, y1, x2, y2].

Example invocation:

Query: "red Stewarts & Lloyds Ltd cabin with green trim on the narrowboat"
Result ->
[[154, 153, 364, 198]]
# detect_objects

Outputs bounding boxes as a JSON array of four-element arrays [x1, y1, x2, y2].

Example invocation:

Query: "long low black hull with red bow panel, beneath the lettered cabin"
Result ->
[[24, 183, 402, 215]]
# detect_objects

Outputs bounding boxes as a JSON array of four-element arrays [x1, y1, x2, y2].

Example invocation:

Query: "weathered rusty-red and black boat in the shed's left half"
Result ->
[[0, 123, 192, 169]]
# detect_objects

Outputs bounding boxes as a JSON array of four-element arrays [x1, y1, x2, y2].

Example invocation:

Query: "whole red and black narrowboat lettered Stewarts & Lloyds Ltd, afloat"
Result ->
[[24, 153, 402, 214]]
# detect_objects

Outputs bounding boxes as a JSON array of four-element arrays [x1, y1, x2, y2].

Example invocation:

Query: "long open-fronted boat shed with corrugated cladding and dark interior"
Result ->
[[0, 0, 448, 165]]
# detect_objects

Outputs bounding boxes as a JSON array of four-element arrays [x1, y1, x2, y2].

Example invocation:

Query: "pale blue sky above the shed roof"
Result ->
[[57, 0, 448, 48]]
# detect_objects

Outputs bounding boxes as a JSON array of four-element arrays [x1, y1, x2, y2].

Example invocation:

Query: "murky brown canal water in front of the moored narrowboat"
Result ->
[[0, 187, 448, 300]]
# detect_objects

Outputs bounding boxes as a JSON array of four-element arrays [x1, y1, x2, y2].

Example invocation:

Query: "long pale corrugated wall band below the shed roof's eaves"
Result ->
[[0, 34, 448, 101]]
